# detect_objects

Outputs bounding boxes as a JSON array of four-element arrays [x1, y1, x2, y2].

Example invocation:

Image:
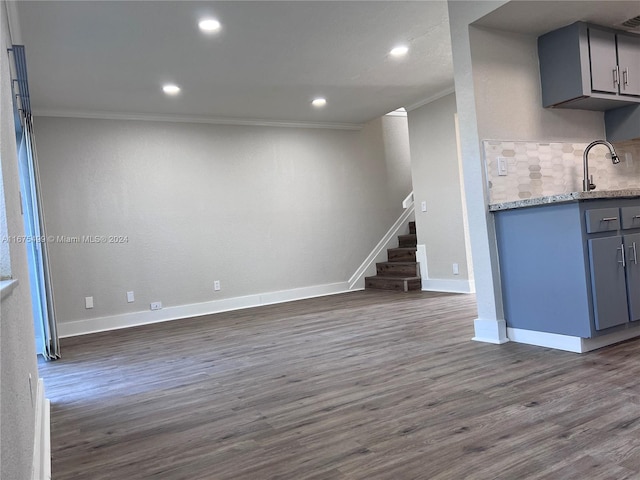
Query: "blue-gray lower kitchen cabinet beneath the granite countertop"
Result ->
[[494, 198, 640, 338]]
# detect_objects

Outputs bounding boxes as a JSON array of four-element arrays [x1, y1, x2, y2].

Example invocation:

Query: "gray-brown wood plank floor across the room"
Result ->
[[40, 291, 640, 480]]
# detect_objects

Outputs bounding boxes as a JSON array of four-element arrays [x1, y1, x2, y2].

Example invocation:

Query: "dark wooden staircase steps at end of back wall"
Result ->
[[364, 222, 422, 292]]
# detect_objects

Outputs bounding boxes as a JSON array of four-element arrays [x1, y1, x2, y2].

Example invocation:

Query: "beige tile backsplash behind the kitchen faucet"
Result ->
[[482, 140, 640, 203]]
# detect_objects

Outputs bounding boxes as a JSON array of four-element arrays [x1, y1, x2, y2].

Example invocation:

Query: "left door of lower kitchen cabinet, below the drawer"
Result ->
[[589, 236, 629, 330]]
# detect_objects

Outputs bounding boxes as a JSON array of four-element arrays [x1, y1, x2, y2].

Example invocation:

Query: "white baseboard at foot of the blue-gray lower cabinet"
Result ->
[[507, 327, 640, 353]]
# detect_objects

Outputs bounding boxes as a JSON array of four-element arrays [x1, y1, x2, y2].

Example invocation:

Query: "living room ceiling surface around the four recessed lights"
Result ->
[[12, 0, 453, 124]]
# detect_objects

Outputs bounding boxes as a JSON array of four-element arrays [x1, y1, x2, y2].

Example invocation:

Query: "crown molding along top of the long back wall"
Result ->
[[33, 109, 363, 130]]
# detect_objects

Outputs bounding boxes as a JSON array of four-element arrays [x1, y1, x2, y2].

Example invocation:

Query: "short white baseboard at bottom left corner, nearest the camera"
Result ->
[[31, 378, 51, 480]]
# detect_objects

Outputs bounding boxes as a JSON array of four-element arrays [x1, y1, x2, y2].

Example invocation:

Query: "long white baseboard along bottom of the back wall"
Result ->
[[58, 282, 351, 338]]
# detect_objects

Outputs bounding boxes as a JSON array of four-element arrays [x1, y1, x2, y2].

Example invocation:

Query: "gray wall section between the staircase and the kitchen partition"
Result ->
[[408, 94, 470, 282]]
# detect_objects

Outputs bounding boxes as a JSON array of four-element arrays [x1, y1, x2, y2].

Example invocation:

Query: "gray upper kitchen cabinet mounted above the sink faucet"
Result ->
[[538, 22, 640, 111]]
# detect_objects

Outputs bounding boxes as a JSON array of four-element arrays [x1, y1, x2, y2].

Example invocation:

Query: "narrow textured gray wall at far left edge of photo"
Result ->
[[0, 2, 38, 480]]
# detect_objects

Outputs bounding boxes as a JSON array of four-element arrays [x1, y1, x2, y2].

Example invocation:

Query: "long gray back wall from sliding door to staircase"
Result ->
[[35, 117, 411, 327]]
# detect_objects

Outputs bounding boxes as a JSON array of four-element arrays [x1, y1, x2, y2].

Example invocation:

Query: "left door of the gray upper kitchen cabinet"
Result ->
[[589, 28, 618, 93]]
